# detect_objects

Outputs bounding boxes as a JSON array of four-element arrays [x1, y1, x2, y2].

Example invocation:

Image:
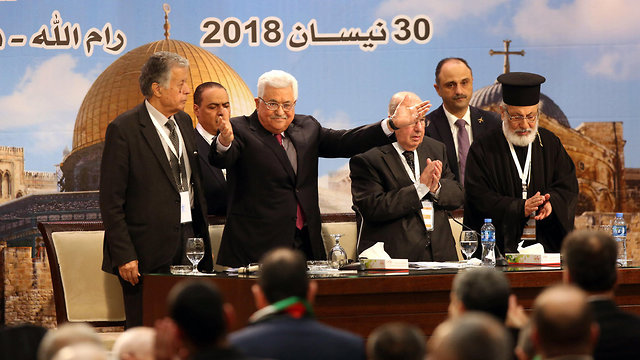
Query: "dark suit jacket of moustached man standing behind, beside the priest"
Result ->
[[425, 105, 502, 182]]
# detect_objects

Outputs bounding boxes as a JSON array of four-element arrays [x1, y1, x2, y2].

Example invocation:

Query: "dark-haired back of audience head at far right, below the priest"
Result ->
[[562, 230, 618, 293]]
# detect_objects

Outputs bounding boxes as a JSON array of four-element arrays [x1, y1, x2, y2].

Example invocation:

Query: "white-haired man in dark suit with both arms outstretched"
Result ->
[[209, 70, 430, 267]]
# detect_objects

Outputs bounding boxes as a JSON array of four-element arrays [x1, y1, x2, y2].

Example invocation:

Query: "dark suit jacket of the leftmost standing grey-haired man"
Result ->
[[100, 103, 213, 274]]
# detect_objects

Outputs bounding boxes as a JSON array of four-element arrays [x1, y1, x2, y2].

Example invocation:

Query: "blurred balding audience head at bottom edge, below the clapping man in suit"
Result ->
[[427, 312, 513, 360]]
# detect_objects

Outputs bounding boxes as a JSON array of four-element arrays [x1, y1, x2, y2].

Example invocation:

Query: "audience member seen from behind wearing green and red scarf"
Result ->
[[229, 248, 365, 360]]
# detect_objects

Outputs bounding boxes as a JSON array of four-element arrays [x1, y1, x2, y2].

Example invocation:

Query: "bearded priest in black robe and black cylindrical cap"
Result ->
[[464, 72, 578, 252]]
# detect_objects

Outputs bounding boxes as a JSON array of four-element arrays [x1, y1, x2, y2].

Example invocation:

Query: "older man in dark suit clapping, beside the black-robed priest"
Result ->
[[349, 92, 464, 261]]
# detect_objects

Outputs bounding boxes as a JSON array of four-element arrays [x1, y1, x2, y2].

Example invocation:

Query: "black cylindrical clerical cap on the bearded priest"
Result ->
[[498, 72, 546, 106]]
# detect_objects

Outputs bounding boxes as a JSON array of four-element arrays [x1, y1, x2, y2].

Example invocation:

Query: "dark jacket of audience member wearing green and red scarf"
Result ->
[[229, 315, 365, 360]]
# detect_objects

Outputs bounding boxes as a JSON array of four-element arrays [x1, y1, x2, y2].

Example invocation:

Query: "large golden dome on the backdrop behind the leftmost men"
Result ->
[[72, 40, 255, 153]]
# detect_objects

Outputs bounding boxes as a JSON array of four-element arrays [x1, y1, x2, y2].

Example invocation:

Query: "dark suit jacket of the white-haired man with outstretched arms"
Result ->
[[209, 112, 389, 267]]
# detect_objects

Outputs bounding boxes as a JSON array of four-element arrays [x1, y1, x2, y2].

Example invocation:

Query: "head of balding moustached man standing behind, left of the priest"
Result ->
[[433, 58, 473, 117]]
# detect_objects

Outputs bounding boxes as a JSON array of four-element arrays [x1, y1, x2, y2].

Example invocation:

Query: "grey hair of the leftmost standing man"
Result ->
[[138, 51, 189, 99]]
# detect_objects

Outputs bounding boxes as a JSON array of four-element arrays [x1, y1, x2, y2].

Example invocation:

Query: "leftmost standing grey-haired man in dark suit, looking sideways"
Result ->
[[100, 52, 213, 328]]
